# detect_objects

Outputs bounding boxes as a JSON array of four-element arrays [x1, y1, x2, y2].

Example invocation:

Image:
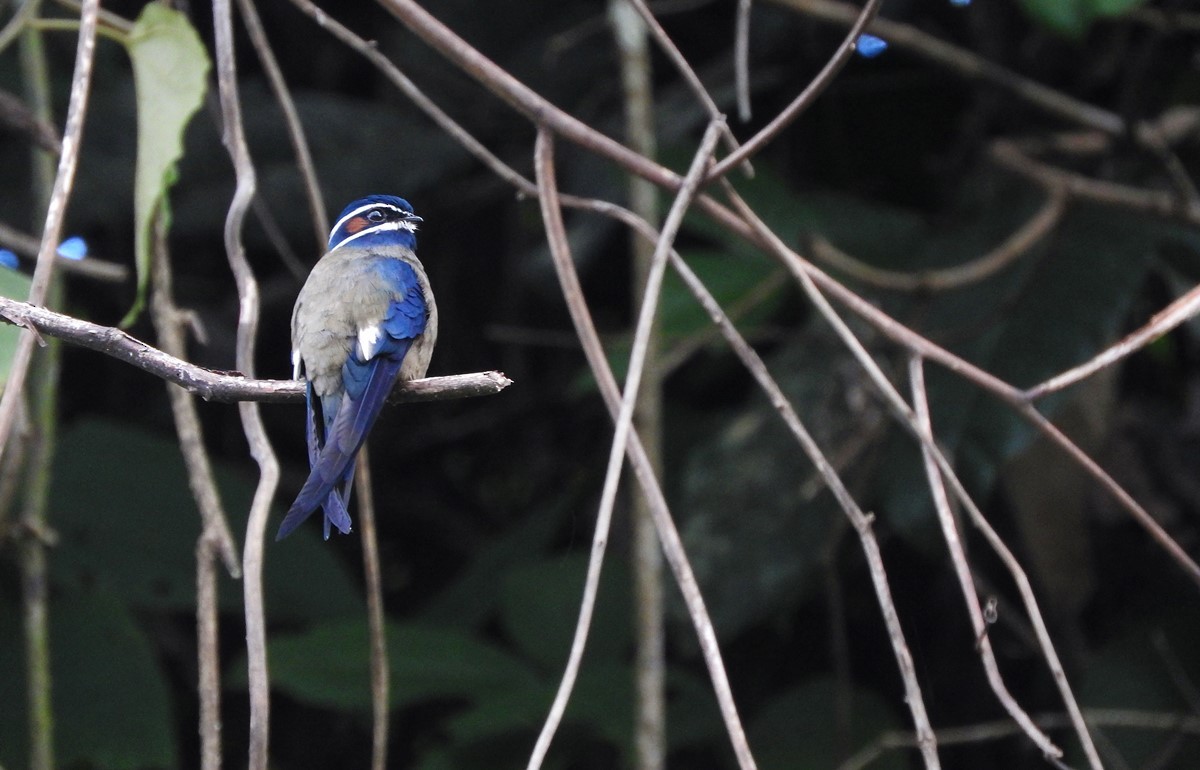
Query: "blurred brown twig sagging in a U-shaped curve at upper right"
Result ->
[[811, 186, 1067, 291]]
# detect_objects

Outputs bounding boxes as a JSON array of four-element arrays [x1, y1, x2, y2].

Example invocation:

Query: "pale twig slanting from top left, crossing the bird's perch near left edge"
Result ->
[[0, 0, 100, 459]]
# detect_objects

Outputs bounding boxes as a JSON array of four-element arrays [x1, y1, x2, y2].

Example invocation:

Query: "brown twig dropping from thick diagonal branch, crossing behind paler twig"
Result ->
[[535, 130, 756, 770]]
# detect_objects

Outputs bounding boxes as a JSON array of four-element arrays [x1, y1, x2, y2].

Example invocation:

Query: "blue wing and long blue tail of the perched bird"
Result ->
[[276, 259, 427, 540]]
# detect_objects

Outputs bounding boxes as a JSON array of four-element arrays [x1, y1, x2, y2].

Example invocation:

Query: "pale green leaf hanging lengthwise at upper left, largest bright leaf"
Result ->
[[121, 2, 209, 326]]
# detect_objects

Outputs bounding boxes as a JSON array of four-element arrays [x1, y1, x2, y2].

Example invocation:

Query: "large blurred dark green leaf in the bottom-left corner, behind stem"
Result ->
[[0, 585, 179, 770]]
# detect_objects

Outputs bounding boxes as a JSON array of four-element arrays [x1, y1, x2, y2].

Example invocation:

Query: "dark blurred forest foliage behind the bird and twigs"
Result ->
[[0, 0, 1200, 770]]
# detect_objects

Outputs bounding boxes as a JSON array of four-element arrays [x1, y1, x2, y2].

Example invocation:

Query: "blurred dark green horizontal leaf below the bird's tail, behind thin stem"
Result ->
[[246, 620, 539, 712]]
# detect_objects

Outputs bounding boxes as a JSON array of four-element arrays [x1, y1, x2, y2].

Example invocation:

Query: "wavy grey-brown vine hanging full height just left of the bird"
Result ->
[[212, 0, 280, 770]]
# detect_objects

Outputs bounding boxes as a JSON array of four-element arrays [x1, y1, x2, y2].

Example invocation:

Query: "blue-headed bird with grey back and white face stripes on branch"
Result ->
[[275, 195, 438, 540]]
